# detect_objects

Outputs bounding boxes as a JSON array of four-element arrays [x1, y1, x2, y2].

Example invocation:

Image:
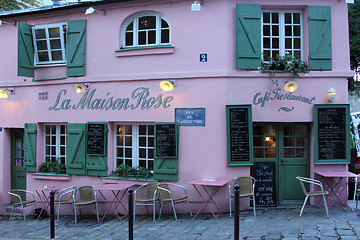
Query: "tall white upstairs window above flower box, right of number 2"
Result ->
[[262, 11, 302, 61]]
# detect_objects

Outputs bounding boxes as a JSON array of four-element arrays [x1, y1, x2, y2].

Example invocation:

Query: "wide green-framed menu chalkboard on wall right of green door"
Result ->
[[314, 104, 350, 163]]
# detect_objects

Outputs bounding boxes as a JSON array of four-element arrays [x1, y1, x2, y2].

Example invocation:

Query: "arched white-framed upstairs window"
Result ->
[[122, 13, 170, 47]]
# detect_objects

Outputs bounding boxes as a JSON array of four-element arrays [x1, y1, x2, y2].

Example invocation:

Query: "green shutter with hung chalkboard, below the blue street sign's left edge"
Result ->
[[154, 123, 179, 181]]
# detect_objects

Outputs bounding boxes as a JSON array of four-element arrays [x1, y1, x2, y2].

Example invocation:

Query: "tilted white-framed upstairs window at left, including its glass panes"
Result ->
[[32, 23, 66, 66]]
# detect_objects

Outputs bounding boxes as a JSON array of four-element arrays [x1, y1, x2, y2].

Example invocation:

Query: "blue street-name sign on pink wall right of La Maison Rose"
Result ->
[[175, 108, 205, 126]]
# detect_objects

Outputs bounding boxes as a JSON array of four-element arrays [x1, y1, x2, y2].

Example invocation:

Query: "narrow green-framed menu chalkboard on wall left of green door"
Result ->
[[226, 105, 252, 165]]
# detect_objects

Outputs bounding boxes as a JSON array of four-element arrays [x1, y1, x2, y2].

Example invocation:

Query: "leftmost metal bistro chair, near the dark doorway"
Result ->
[[8, 189, 36, 221]]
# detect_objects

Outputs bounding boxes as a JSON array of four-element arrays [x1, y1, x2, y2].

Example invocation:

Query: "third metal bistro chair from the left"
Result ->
[[73, 186, 99, 224]]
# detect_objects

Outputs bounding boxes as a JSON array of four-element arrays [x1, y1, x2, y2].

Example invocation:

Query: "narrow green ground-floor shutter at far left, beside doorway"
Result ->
[[24, 123, 36, 172]]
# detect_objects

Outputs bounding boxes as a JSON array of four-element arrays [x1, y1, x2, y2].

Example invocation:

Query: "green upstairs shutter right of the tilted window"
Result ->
[[66, 19, 86, 77]]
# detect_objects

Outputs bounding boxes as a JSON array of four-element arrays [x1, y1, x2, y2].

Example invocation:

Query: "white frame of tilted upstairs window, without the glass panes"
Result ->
[[32, 23, 67, 67]]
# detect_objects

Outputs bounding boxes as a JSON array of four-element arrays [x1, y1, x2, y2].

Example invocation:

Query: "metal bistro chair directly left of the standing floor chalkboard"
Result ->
[[229, 176, 256, 217]]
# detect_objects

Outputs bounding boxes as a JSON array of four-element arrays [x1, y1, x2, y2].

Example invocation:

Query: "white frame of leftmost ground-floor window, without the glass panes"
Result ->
[[44, 123, 67, 164]]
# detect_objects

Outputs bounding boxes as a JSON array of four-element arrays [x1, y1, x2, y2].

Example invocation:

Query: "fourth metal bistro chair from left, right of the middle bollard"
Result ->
[[134, 182, 159, 221]]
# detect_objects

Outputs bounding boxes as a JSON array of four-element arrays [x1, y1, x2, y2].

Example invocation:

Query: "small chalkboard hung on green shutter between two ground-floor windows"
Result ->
[[87, 123, 106, 155]]
